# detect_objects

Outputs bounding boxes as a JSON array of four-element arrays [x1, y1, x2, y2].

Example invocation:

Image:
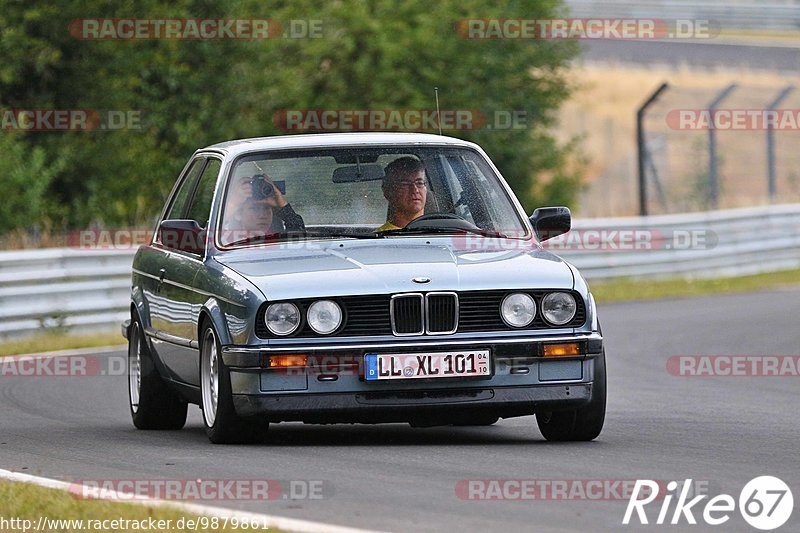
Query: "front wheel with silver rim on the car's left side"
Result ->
[[200, 321, 269, 444]]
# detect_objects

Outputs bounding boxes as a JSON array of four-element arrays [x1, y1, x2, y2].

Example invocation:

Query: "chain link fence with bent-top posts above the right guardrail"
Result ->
[[642, 84, 800, 214]]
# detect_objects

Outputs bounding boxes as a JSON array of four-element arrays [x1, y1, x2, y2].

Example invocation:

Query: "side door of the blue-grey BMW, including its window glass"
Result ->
[[160, 157, 222, 385]]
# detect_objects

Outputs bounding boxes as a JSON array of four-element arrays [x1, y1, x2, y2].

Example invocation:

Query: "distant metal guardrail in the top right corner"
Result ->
[[566, 0, 800, 31]]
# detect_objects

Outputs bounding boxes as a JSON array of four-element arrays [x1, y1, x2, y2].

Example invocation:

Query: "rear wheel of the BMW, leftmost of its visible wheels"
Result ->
[[128, 313, 188, 430]]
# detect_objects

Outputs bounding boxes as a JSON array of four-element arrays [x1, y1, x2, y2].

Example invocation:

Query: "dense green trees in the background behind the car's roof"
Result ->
[[0, 0, 578, 231]]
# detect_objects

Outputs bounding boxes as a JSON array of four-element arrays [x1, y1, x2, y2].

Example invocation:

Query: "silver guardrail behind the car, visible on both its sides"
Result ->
[[0, 204, 800, 340]]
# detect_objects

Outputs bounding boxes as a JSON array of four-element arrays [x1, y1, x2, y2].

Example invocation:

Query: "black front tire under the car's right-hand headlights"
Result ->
[[536, 351, 606, 441]]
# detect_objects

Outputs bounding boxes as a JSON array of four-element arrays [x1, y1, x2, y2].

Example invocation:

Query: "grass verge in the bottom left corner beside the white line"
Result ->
[[0, 481, 286, 533]]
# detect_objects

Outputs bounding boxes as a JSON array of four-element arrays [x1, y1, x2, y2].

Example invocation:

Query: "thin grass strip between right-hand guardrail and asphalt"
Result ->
[[590, 269, 800, 303]]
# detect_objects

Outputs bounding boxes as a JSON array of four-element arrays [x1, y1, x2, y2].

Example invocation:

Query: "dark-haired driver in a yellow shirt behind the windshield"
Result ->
[[375, 156, 428, 231]]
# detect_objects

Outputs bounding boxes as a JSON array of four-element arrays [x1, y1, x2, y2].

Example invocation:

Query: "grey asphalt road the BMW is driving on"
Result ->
[[0, 289, 800, 532]]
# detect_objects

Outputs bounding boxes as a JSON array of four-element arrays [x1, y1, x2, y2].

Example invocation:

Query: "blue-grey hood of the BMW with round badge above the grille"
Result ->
[[216, 239, 574, 301]]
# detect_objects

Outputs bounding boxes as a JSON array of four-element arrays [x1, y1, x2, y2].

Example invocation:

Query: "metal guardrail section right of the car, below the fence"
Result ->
[[553, 204, 800, 281]]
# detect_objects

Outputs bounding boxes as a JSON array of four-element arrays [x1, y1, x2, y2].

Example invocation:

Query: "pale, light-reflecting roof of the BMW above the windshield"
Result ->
[[198, 133, 478, 156]]
